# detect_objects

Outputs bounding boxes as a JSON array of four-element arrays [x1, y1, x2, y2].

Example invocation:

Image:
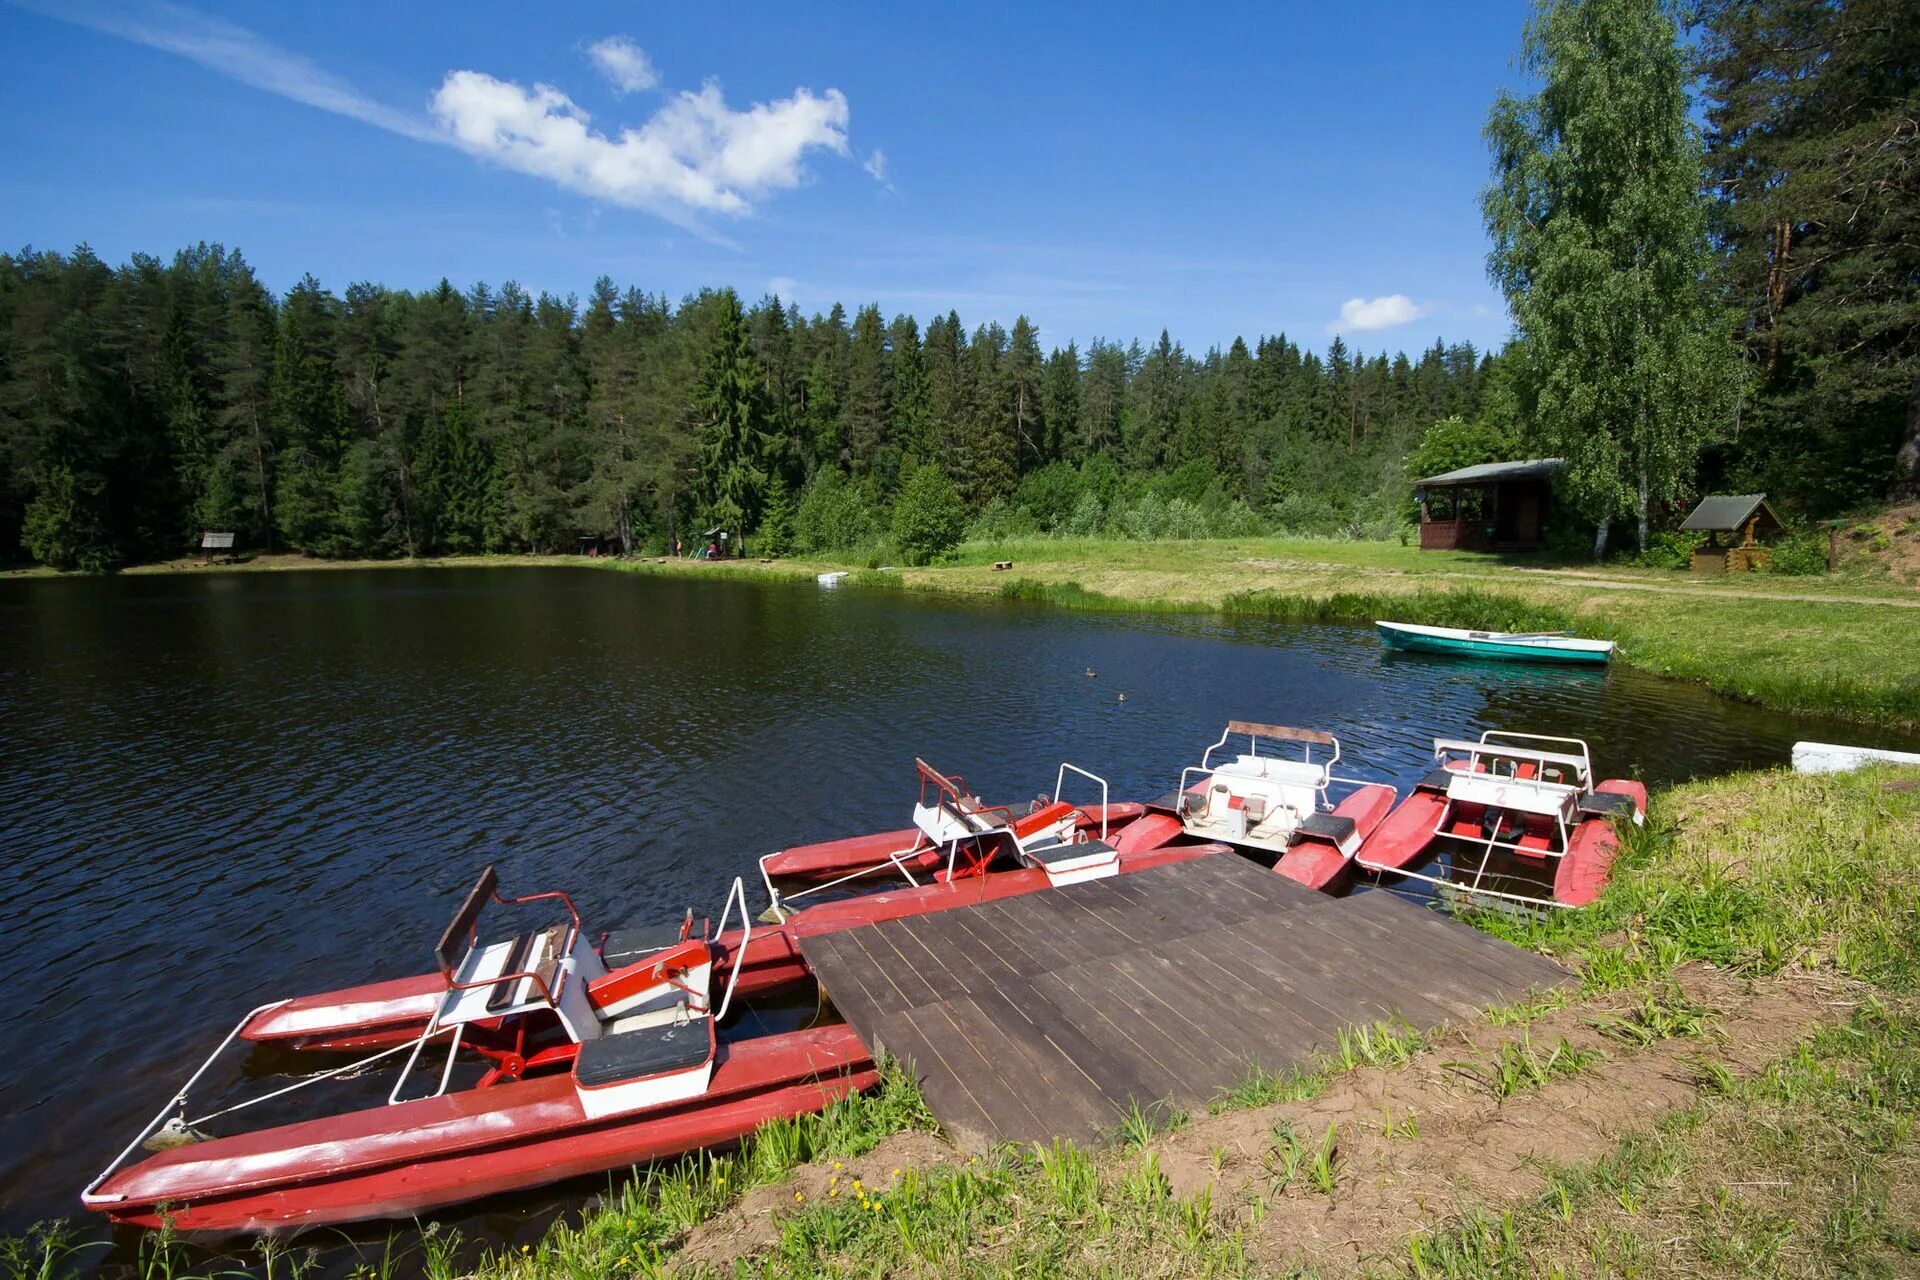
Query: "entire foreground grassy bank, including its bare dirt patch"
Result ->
[[18, 770, 1920, 1280]]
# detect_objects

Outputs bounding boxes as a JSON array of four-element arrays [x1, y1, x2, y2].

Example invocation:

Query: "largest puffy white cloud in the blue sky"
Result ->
[[430, 71, 847, 215]]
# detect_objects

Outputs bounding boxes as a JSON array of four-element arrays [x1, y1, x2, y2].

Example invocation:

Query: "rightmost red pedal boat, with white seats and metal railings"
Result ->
[[1357, 729, 1647, 908]]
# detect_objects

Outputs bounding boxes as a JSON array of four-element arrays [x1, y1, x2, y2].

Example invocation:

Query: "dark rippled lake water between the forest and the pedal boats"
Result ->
[[0, 568, 1896, 1230]]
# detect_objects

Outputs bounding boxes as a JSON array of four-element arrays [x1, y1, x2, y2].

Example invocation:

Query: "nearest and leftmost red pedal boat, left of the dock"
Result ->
[[81, 867, 877, 1232]]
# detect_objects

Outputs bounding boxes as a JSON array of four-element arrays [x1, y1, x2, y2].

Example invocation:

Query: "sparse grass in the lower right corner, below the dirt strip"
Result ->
[[1392, 1002, 1920, 1280]]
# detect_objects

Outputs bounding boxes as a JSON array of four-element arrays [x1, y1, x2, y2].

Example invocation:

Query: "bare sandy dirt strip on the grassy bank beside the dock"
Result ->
[[1158, 967, 1851, 1274]]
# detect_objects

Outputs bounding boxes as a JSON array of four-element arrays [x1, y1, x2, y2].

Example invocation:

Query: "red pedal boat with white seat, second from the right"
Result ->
[[1175, 720, 1394, 889]]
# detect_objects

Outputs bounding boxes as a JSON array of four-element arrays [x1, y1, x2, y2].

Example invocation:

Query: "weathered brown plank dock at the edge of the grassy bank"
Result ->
[[801, 854, 1571, 1148]]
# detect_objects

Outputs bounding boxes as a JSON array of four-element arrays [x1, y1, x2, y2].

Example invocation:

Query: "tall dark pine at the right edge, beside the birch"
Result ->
[[1703, 0, 1920, 510]]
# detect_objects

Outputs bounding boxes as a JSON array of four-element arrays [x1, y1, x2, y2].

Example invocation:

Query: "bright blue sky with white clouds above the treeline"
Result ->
[[0, 0, 1526, 351]]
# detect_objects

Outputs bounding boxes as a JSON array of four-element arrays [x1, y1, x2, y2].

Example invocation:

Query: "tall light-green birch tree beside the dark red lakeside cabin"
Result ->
[[1484, 0, 1732, 558]]
